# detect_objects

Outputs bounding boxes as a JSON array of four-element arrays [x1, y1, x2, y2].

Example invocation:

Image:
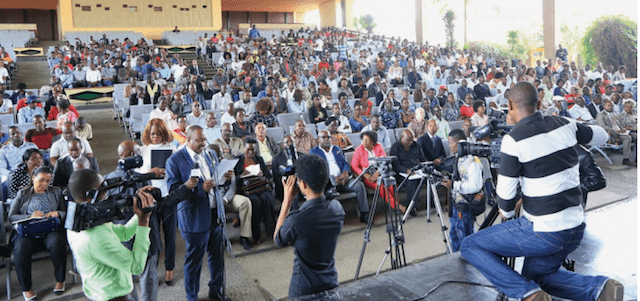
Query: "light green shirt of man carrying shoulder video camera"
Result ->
[[67, 216, 151, 301]]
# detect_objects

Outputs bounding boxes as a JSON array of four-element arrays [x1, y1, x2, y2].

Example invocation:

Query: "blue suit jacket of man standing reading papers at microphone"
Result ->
[[166, 147, 215, 233]]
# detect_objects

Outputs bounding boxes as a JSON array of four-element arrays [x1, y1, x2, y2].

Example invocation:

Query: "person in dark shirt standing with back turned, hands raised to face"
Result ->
[[273, 155, 345, 299]]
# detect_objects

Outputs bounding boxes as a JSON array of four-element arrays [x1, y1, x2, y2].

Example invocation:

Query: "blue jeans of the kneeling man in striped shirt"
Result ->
[[460, 217, 608, 300]]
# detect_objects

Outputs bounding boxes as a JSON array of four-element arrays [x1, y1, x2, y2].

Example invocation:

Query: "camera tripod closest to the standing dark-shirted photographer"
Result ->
[[354, 157, 407, 280]]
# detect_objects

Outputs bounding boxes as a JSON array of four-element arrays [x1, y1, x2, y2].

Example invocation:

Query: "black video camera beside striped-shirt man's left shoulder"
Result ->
[[458, 118, 513, 169]]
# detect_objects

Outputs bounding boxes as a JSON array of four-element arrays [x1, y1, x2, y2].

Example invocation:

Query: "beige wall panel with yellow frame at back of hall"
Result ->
[[58, 0, 222, 39]]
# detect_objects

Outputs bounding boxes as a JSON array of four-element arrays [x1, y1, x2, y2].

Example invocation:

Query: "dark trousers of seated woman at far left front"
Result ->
[[13, 227, 67, 291]]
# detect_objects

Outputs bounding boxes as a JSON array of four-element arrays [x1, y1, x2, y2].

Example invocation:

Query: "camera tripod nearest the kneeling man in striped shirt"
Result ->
[[398, 164, 453, 254]]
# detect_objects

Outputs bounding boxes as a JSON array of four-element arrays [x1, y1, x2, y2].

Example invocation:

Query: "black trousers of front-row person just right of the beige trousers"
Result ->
[[247, 191, 276, 240]]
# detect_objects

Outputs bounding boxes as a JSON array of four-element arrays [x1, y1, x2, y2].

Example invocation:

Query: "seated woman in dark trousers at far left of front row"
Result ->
[[9, 167, 67, 301]]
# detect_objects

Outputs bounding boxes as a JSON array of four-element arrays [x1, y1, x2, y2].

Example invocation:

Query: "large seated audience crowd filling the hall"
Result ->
[[0, 28, 637, 298]]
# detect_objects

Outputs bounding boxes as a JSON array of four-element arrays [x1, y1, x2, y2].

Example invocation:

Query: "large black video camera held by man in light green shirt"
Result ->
[[64, 156, 164, 232]]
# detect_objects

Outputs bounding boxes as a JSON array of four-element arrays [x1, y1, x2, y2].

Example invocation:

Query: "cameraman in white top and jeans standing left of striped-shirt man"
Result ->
[[442, 129, 484, 252]]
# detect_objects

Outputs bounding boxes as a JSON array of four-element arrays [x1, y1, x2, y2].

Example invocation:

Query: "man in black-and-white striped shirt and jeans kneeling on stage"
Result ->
[[460, 82, 624, 301]]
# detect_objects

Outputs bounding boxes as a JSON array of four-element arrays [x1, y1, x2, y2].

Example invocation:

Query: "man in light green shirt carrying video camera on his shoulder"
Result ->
[[67, 169, 153, 301]]
